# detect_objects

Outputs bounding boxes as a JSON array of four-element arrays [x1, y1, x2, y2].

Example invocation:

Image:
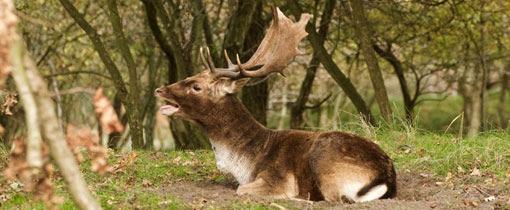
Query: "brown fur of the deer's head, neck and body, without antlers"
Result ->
[[156, 71, 396, 201]]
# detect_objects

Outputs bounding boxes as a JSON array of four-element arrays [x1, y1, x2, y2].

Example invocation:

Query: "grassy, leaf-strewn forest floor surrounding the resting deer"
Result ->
[[0, 133, 510, 210]]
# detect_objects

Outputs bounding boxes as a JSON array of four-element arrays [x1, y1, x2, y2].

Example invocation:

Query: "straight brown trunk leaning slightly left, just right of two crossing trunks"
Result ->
[[349, 0, 391, 122]]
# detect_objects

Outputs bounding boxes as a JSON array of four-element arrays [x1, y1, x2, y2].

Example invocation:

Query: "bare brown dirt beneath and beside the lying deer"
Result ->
[[160, 172, 510, 210]]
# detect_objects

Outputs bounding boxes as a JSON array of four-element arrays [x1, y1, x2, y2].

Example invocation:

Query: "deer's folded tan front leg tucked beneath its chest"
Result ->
[[237, 174, 299, 199]]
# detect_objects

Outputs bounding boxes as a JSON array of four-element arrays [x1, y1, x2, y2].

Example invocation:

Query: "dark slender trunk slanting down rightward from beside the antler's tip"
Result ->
[[289, 0, 376, 125]]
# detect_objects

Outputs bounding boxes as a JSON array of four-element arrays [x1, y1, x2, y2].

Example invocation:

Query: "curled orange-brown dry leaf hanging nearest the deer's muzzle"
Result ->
[[94, 88, 124, 134]]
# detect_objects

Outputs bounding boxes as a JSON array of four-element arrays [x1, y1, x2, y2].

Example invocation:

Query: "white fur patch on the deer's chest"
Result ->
[[211, 141, 254, 185]]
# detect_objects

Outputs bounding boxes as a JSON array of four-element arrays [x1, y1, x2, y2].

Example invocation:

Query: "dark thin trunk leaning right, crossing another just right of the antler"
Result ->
[[290, 0, 336, 128]]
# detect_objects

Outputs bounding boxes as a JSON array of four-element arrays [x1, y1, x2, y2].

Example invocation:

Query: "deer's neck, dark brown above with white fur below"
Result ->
[[195, 96, 271, 184]]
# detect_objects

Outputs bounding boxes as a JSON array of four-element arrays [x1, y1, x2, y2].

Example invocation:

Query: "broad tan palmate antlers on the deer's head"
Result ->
[[200, 7, 311, 79]]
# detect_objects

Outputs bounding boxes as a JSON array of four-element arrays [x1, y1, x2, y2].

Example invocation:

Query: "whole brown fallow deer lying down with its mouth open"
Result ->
[[155, 8, 397, 202]]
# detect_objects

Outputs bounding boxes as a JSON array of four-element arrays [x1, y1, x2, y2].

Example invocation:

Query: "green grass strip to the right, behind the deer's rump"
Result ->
[[375, 132, 510, 177]]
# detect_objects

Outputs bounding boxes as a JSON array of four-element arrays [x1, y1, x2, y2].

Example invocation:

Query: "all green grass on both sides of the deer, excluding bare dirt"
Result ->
[[0, 130, 510, 209]]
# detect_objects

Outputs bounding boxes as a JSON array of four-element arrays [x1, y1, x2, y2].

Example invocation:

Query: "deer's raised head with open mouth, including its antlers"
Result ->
[[156, 7, 311, 121]]
